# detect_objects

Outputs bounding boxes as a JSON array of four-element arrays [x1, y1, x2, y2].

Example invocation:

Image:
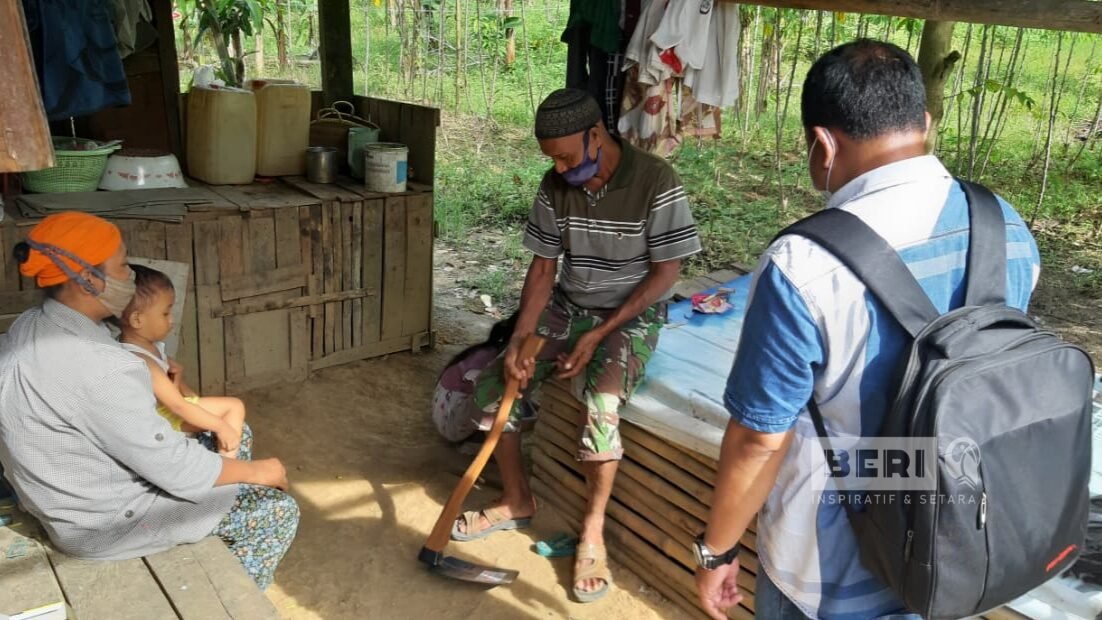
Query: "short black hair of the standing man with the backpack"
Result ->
[[801, 39, 926, 140]]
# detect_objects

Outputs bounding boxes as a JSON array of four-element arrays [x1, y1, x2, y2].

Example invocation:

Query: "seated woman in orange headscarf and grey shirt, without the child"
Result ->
[[0, 213, 299, 588]]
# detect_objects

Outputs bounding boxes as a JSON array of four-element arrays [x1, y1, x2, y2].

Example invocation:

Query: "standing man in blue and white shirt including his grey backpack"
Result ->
[[694, 40, 1092, 620]]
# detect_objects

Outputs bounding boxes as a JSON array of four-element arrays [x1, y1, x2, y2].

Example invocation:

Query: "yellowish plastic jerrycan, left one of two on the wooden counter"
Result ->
[[187, 86, 257, 185]]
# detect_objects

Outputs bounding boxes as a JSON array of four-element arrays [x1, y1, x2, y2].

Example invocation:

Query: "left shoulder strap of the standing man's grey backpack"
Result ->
[[777, 209, 940, 338]]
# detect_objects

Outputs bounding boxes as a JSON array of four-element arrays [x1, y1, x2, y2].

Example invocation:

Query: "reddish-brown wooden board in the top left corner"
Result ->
[[0, 2, 54, 173]]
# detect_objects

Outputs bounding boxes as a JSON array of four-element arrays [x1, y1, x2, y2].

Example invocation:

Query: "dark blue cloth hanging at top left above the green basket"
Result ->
[[23, 0, 130, 120]]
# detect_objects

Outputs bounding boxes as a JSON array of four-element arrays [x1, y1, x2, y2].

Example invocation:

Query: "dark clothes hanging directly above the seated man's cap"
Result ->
[[561, 0, 639, 135]]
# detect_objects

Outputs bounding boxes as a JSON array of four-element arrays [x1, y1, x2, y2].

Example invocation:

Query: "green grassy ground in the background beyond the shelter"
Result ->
[[174, 6, 1102, 298]]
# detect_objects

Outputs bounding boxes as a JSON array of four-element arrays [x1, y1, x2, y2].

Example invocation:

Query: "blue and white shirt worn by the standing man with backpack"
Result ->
[[725, 156, 1040, 619]]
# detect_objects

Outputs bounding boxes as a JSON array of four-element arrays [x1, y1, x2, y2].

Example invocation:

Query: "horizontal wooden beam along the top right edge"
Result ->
[[721, 0, 1102, 33]]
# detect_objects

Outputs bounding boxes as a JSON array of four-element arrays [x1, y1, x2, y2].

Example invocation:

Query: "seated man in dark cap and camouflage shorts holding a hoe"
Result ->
[[452, 89, 701, 602]]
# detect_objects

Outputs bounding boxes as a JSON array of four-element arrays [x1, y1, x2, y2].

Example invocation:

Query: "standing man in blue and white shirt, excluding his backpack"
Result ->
[[696, 40, 1040, 620]]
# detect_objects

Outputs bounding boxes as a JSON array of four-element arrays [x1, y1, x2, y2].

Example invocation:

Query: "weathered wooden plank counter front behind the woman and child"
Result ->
[[0, 178, 432, 394]]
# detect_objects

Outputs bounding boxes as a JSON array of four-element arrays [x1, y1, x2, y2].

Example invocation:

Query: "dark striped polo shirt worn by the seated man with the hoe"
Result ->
[[525, 142, 701, 308]]
